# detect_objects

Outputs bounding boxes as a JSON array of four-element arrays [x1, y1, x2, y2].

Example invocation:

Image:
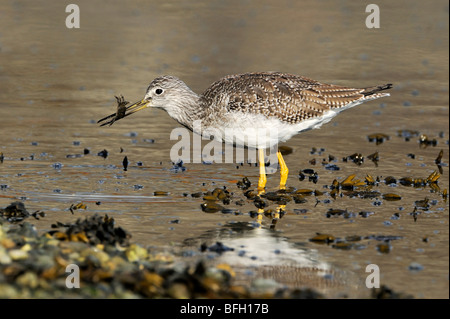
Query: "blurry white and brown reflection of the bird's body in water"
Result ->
[[184, 222, 367, 297]]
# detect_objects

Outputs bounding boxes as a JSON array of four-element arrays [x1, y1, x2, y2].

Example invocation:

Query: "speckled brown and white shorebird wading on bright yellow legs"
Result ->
[[98, 72, 392, 198]]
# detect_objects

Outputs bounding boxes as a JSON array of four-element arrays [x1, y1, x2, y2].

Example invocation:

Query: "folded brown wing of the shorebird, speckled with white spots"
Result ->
[[203, 72, 374, 123]]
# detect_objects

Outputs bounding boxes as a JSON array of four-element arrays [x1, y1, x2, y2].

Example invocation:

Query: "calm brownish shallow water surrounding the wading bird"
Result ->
[[0, 1, 449, 298]]
